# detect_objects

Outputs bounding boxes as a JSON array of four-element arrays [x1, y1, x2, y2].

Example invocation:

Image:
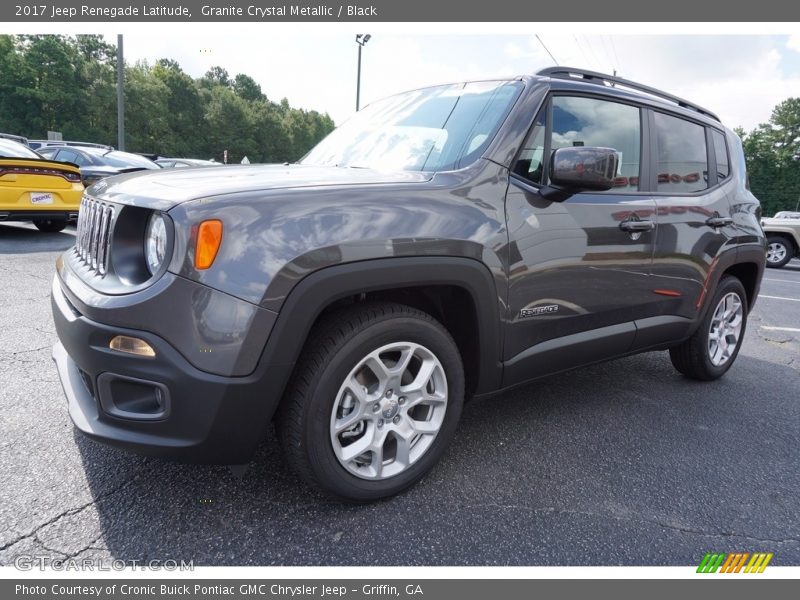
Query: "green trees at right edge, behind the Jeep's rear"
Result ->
[[737, 98, 800, 217]]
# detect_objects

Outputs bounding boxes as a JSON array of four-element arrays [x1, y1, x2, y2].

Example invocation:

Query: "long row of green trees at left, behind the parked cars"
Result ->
[[0, 35, 334, 163]]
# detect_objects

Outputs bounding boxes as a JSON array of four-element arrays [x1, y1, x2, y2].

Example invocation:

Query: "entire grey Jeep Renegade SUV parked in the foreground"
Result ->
[[52, 68, 765, 501]]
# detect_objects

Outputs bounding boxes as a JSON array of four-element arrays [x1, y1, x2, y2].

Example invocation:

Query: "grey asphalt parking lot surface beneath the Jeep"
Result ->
[[0, 224, 800, 565]]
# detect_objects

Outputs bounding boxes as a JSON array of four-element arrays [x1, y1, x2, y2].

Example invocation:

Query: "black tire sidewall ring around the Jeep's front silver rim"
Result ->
[[303, 316, 464, 501]]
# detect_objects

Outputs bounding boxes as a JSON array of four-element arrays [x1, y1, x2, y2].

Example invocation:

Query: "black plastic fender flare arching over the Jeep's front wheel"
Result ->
[[261, 256, 502, 406]]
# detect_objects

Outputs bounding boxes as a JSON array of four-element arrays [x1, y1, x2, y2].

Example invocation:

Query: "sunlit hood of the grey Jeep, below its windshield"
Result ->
[[88, 165, 432, 210]]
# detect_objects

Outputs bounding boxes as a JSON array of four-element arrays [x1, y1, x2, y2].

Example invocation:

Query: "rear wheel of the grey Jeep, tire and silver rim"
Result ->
[[669, 276, 747, 381]]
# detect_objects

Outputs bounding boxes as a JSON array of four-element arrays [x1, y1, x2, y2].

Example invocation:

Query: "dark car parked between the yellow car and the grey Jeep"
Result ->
[[37, 145, 160, 187]]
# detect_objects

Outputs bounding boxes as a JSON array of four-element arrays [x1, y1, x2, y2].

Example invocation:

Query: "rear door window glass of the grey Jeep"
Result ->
[[654, 113, 708, 194]]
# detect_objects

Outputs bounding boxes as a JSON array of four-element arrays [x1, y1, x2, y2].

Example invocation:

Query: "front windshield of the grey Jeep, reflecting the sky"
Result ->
[[300, 81, 523, 171]]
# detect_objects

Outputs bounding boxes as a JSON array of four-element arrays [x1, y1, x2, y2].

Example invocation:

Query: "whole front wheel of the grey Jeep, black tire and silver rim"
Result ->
[[276, 302, 464, 502]]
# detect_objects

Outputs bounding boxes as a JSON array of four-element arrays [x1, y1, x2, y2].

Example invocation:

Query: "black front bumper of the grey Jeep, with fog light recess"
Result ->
[[51, 277, 291, 464]]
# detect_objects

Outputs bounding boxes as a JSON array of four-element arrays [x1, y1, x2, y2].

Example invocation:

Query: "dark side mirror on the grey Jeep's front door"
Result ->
[[550, 146, 619, 194]]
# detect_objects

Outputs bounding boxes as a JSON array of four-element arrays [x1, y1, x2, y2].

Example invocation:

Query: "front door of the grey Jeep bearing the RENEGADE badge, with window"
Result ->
[[504, 94, 659, 385]]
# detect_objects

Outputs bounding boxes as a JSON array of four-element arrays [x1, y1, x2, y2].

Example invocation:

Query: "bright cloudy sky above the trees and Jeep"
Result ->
[[107, 30, 800, 130]]
